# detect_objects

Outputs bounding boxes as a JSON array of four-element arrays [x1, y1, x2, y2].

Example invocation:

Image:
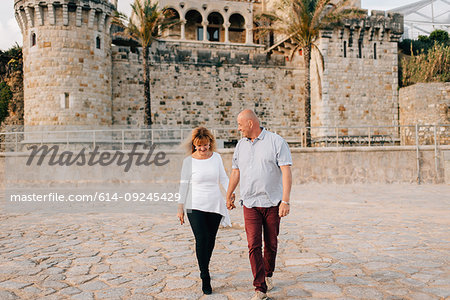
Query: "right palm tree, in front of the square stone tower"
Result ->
[[260, 0, 358, 147]]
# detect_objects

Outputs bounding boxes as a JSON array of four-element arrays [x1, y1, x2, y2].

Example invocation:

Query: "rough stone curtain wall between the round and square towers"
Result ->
[[113, 43, 304, 136]]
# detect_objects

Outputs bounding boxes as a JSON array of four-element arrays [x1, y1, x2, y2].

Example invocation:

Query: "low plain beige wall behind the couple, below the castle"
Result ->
[[0, 146, 450, 188]]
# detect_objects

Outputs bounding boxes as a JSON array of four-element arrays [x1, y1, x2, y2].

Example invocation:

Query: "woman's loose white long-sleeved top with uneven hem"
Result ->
[[179, 152, 231, 226]]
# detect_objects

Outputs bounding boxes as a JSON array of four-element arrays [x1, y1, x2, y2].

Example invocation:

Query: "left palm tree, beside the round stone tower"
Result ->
[[114, 0, 177, 126]]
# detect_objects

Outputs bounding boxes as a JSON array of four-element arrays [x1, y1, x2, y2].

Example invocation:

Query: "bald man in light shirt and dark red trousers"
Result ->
[[227, 109, 292, 300]]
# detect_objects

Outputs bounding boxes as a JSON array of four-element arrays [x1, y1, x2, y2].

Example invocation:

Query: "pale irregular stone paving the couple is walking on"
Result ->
[[0, 185, 450, 300]]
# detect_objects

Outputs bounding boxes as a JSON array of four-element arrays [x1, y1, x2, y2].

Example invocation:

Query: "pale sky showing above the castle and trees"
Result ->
[[0, 0, 418, 50]]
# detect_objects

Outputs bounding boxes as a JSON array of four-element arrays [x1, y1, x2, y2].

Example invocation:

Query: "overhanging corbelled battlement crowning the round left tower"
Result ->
[[14, 0, 115, 34]]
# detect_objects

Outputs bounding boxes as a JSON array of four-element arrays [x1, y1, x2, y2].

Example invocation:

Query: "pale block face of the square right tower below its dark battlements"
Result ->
[[311, 24, 398, 135]]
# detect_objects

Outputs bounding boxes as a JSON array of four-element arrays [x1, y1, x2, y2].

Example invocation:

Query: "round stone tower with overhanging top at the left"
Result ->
[[14, 0, 114, 126]]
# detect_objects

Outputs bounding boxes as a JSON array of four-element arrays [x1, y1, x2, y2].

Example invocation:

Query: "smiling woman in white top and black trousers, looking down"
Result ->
[[177, 127, 231, 295]]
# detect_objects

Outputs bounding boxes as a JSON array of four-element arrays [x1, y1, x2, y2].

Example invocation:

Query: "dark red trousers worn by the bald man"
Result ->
[[244, 206, 280, 293]]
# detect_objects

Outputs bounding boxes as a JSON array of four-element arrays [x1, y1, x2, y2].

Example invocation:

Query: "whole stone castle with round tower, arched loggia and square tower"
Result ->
[[15, 0, 403, 143]]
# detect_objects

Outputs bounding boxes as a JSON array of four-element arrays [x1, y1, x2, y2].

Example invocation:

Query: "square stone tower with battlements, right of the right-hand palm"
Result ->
[[311, 11, 403, 135]]
